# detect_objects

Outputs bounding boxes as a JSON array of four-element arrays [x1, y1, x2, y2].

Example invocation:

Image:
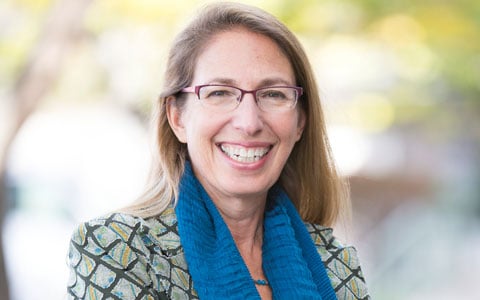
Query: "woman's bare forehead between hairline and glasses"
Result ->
[[194, 28, 295, 84]]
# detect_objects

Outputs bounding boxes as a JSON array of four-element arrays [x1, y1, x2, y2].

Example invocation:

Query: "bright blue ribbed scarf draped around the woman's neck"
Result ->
[[175, 162, 337, 300]]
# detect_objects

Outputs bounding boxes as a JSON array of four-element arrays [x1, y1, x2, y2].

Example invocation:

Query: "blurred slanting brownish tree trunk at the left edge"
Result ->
[[0, 0, 92, 299]]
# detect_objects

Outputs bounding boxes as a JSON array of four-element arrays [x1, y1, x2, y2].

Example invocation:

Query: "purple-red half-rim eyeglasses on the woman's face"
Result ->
[[182, 84, 303, 112]]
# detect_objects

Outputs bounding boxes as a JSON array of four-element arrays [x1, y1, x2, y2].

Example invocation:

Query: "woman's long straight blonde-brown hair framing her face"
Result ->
[[123, 2, 348, 226]]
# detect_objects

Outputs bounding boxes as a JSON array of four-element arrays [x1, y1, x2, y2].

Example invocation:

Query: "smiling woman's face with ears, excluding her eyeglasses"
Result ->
[[168, 29, 305, 201]]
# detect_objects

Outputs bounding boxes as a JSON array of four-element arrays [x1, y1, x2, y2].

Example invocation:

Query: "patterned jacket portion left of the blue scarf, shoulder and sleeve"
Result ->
[[67, 209, 196, 299]]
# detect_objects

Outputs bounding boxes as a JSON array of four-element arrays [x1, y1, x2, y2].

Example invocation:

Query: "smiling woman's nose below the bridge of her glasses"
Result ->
[[232, 93, 264, 136]]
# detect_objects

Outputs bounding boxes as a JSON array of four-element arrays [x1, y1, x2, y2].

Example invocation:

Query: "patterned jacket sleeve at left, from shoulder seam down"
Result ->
[[67, 214, 163, 300]]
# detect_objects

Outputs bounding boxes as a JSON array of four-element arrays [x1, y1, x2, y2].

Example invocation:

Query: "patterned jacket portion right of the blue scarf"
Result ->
[[305, 223, 369, 299]]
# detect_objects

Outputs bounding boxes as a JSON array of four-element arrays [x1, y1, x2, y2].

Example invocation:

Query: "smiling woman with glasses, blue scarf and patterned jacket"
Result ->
[[68, 3, 369, 299]]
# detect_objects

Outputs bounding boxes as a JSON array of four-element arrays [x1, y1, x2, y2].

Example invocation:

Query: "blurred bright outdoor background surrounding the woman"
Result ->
[[0, 0, 480, 300]]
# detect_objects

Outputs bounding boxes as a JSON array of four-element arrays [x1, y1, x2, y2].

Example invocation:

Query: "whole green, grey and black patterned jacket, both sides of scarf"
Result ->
[[67, 208, 370, 300]]
